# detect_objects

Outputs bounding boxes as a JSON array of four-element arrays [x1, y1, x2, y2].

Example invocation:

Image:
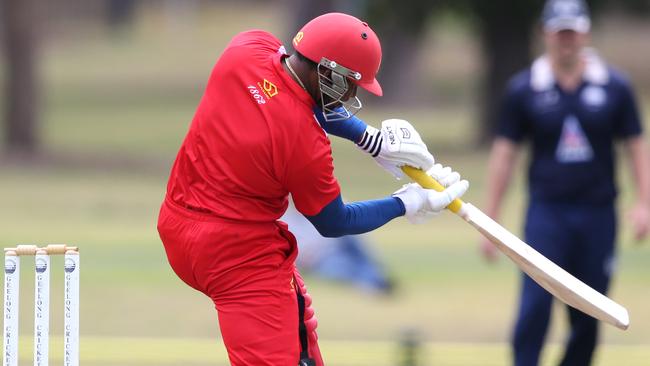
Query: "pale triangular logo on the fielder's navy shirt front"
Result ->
[[555, 115, 594, 163]]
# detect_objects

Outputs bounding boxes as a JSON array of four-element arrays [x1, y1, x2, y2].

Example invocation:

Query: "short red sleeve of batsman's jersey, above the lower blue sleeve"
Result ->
[[285, 126, 341, 216]]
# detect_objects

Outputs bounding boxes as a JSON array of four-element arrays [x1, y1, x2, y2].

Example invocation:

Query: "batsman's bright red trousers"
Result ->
[[158, 200, 323, 366]]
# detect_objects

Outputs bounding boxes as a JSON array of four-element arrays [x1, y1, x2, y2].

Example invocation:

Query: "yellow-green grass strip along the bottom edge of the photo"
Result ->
[[10, 337, 647, 366]]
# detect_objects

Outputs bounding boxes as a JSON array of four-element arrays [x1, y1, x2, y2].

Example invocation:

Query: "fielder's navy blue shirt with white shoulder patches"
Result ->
[[497, 54, 642, 205]]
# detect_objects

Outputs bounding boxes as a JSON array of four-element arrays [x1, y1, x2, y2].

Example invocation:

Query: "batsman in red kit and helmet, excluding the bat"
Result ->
[[158, 13, 468, 366]]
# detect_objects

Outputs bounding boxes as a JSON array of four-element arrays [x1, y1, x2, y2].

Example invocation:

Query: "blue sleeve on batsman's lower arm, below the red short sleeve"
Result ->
[[306, 195, 405, 238]]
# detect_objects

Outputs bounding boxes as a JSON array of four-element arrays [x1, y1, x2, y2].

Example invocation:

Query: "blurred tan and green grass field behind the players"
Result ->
[[0, 5, 650, 366]]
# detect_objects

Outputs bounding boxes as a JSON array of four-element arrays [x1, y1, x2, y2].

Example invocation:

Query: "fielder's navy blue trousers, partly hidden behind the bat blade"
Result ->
[[513, 202, 617, 366]]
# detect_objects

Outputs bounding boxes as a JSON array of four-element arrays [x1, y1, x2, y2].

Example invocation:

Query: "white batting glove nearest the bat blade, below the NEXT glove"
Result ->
[[393, 164, 469, 224]]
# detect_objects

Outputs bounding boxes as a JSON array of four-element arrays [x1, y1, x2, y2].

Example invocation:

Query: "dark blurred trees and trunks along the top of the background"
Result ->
[[0, 0, 650, 156]]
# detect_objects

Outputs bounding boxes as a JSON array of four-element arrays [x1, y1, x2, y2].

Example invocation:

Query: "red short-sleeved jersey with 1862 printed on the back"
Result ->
[[167, 30, 340, 222]]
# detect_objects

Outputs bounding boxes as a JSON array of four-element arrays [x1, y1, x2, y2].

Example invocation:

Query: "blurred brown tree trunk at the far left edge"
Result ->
[[0, 0, 40, 155]]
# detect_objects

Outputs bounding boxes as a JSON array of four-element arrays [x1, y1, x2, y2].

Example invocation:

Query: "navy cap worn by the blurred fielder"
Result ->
[[542, 0, 591, 33]]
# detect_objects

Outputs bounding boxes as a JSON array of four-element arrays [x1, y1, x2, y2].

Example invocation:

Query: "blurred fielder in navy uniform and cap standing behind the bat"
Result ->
[[482, 0, 650, 366]]
